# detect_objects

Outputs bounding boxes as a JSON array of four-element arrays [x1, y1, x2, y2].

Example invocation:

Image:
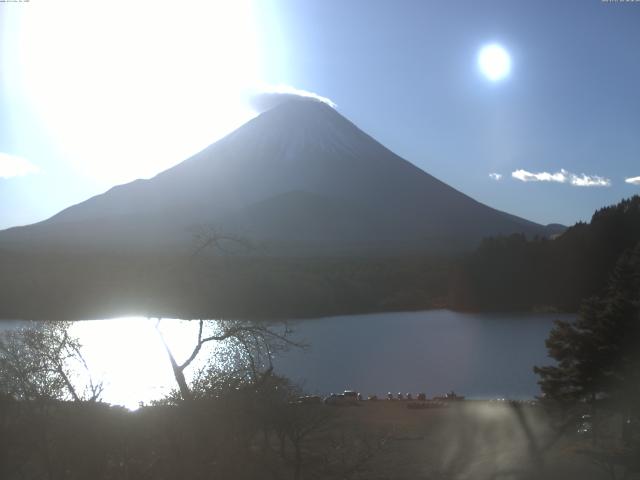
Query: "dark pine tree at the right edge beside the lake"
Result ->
[[534, 243, 640, 413]]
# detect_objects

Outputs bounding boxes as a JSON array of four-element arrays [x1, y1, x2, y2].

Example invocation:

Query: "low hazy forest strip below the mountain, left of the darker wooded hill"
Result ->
[[0, 251, 451, 320]]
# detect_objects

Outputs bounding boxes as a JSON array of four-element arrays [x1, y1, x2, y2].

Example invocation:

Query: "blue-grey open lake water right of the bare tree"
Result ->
[[276, 310, 570, 399]]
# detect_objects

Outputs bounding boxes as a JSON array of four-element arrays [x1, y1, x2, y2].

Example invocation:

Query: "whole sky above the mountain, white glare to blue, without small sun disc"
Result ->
[[0, 0, 640, 228]]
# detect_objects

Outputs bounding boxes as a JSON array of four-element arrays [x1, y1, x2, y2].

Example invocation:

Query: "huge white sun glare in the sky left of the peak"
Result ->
[[16, 0, 261, 183]]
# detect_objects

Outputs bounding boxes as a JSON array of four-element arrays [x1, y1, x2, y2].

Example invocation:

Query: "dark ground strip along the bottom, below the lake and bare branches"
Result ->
[[0, 390, 633, 480]]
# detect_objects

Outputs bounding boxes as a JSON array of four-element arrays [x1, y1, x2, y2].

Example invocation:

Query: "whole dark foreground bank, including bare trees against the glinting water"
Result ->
[[0, 316, 636, 480]]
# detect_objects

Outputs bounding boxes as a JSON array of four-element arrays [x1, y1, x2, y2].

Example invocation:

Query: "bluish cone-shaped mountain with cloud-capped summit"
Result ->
[[0, 100, 556, 255]]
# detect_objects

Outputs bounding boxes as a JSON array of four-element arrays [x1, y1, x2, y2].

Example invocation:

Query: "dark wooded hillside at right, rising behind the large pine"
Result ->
[[449, 195, 640, 312]]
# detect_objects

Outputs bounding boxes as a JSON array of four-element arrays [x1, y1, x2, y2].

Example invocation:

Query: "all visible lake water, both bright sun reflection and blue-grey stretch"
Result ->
[[0, 310, 570, 408]]
